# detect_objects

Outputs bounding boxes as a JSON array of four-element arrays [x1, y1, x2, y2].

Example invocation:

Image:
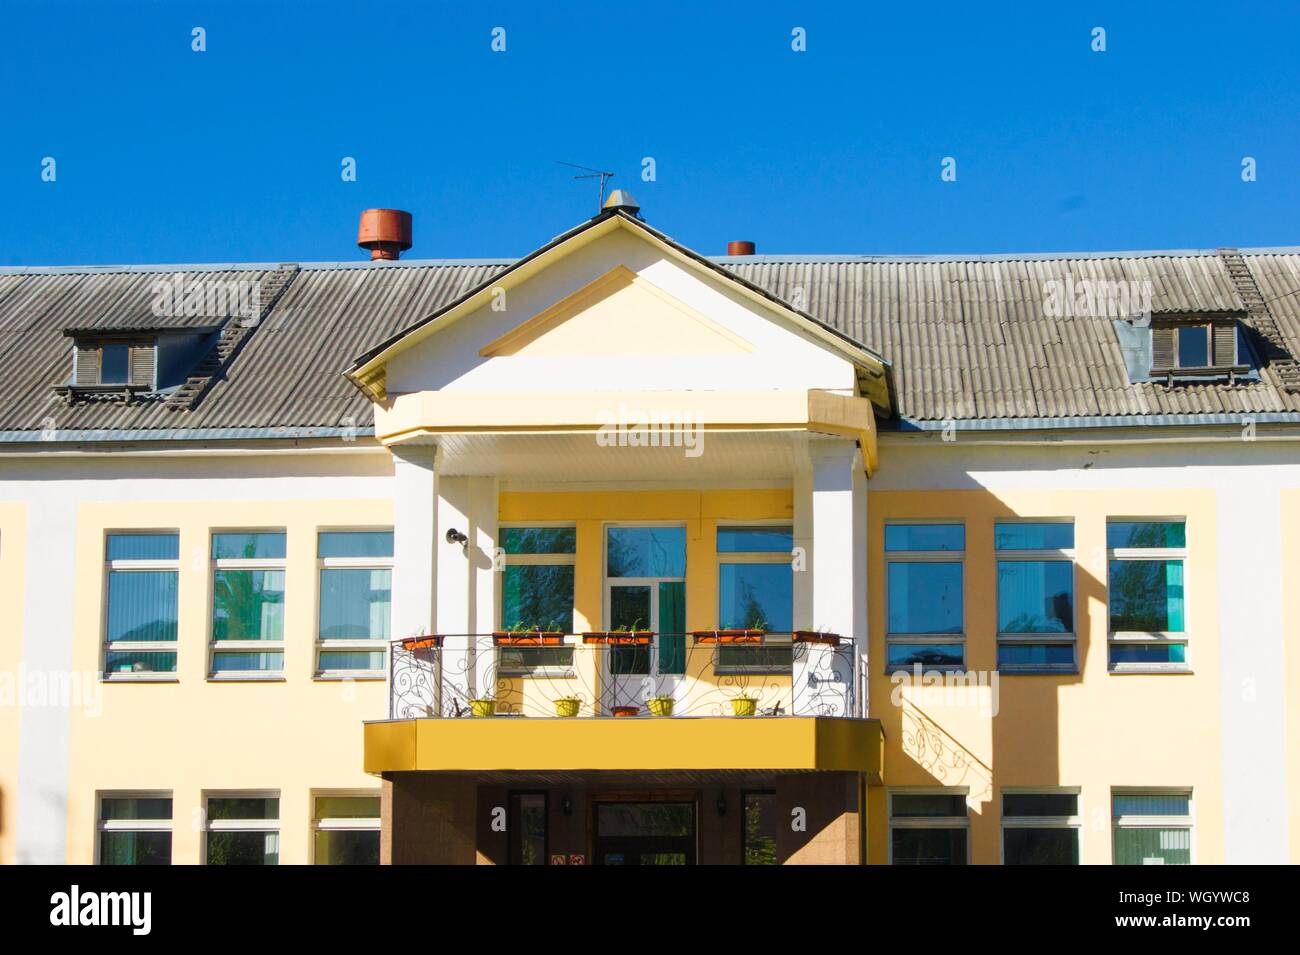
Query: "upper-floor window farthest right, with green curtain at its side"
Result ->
[[1106, 520, 1187, 673]]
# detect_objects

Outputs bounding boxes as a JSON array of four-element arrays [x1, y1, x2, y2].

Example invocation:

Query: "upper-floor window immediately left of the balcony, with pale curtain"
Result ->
[[316, 530, 393, 677]]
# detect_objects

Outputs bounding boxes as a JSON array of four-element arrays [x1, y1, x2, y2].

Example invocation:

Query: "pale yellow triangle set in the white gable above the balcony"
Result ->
[[478, 265, 754, 357]]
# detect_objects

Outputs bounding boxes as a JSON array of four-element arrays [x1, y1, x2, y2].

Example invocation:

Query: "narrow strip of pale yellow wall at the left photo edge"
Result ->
[[0, 503, 27, 865]]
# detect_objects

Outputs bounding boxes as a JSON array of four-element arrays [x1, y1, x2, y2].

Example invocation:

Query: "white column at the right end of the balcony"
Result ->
[[794, 438, 867, 716]]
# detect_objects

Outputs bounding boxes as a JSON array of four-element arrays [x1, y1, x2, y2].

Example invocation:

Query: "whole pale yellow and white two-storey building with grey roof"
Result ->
[[0, 192, 1300, 864]]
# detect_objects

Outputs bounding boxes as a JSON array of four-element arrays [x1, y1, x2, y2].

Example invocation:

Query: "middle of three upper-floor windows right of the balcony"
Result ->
[[993, 521, 1076, 673]]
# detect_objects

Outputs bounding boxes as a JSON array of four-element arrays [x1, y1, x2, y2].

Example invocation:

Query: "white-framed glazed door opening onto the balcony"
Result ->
[[601, 525, 686, 712]]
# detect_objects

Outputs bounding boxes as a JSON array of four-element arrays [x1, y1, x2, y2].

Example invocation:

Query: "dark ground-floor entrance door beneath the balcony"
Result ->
[[594, 802, 696, 865]]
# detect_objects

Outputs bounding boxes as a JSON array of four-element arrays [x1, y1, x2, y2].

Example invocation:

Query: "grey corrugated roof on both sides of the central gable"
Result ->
[[0, 242, 1300, 437]]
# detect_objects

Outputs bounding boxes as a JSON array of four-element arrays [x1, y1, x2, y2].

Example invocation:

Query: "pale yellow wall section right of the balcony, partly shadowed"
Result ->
[[867, 490, 1222, 864]]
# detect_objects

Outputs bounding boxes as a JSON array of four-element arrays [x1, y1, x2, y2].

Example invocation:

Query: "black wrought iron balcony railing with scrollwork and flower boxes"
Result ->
[[389, 630, 867, 720]]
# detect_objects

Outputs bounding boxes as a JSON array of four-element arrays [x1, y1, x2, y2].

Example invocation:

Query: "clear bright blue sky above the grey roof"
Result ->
[[0, 0, 1300, 265]]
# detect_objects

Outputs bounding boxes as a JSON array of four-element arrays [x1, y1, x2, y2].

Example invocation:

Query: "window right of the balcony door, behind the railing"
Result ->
[[715, 524, 794, 673]]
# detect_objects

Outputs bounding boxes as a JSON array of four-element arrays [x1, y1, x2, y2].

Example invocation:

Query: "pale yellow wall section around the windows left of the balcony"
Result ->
[[68, 500, 393, 864]]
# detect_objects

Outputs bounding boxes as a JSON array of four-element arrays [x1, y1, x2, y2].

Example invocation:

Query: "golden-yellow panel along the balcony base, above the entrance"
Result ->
[[365, 716, 884, 783]]
